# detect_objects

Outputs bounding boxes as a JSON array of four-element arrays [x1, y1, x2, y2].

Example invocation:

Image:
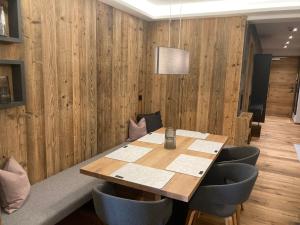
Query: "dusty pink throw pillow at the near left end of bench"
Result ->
[[0, 157, 30, 214]]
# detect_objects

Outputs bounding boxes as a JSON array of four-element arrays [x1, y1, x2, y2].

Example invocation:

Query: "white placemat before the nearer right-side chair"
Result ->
[[166, 154, 212, 177]]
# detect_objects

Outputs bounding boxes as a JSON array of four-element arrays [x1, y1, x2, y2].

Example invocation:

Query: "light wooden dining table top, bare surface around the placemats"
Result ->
[[80, 128, 228, 202]]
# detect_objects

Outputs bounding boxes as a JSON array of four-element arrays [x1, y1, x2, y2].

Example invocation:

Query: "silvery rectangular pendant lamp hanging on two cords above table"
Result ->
[[154, 0, 190, 75]]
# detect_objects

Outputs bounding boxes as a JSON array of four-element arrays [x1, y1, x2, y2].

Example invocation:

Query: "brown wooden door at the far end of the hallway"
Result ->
[[266, 57, 299, 117]]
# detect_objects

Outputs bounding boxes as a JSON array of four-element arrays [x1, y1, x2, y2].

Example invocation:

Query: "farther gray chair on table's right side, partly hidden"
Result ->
[[216, 146, 260, 166]]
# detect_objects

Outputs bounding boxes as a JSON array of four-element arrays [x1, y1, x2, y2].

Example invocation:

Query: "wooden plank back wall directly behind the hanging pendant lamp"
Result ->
[[141, 17, 246, 143]]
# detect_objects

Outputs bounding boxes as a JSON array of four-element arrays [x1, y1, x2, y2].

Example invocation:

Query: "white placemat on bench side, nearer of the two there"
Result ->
[[105, 145, 153, 162]]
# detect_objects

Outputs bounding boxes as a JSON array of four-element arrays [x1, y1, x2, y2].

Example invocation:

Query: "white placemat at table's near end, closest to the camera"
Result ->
[[111, 163, 175, 189]]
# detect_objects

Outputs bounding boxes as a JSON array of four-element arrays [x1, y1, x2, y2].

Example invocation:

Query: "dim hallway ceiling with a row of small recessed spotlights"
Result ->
[[256, 19, 300, 56]]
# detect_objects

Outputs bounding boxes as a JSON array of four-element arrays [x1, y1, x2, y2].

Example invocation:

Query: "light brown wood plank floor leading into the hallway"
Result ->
[[194, 117, 300, 225]]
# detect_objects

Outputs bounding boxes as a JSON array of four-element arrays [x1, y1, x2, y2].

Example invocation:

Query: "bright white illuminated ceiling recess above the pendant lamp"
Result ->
[[116, 0, 300, 19]]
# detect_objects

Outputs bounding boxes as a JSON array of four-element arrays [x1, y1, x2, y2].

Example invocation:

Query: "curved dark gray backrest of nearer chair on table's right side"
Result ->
[[190, 163, 258, 208]]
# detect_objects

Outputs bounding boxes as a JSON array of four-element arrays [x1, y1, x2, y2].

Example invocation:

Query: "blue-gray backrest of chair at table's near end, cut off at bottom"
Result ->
[[92, 183, 172, 225]]
